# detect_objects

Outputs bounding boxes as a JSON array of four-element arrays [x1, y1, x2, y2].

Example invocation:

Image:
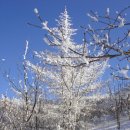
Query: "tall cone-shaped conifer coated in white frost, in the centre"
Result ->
[[26, 9, 107, 130]]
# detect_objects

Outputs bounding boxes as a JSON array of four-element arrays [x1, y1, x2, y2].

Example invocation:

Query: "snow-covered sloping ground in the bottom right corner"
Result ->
[[90, 117, 130, 130]]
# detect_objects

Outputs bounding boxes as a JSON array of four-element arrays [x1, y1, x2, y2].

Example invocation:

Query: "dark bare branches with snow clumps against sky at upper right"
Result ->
[[81, 6, 130, 80]]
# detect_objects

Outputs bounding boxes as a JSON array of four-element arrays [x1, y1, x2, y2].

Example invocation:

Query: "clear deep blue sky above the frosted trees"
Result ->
[[0, 0, 130, 93]]
